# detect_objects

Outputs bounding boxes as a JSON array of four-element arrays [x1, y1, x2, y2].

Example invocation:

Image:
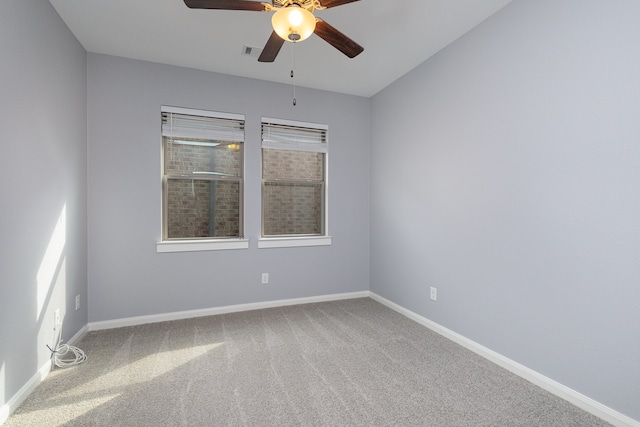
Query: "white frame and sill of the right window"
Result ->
[[258, 117, 332, 249]]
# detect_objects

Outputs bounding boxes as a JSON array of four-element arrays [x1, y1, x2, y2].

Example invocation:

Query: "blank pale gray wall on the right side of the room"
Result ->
[[370, 0, 640, 420]]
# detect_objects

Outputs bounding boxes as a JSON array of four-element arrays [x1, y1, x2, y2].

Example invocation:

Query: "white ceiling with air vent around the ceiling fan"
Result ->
[[49, 0, 511, 97]]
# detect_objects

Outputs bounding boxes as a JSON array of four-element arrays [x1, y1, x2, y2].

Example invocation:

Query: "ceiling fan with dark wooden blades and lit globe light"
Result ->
[[184, 0, 364, 62]]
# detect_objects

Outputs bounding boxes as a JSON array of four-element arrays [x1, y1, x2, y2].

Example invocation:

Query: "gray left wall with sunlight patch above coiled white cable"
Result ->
[[0, 0, 87, 414]]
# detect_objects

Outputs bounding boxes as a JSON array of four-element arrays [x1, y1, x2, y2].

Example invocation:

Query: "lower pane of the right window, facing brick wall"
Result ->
[[263, 182, 323, 236]]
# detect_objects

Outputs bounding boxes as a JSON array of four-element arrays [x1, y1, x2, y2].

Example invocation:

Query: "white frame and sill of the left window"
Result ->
[[156, 106, 249, 253]]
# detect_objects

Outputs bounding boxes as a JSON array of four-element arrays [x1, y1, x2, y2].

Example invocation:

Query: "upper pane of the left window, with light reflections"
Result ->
[[164, 137, 242, 177]]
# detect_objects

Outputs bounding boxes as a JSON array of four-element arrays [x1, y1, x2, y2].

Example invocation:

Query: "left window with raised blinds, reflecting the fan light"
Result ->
[[159, 107, 244, 247]]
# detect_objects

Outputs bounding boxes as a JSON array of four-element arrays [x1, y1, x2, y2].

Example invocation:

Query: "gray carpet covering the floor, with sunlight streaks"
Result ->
[[5, 298, 608, 427]]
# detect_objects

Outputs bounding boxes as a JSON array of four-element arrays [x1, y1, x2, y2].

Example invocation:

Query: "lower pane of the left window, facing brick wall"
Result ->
[[167, 179, 240, 239]]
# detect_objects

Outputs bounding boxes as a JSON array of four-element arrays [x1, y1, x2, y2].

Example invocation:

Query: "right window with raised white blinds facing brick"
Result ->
[[259, 118, 328, 247]]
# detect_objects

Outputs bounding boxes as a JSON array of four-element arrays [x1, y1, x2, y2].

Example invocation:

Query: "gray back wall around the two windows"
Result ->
[[88, 54, 370, 321]]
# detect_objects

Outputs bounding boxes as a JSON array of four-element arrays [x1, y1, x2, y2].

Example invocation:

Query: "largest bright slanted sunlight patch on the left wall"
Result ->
[[36, 204, 67, 321]]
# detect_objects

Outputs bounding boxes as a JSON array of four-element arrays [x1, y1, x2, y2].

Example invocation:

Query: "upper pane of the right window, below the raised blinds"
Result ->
[[262, 148, 324, 181]]
